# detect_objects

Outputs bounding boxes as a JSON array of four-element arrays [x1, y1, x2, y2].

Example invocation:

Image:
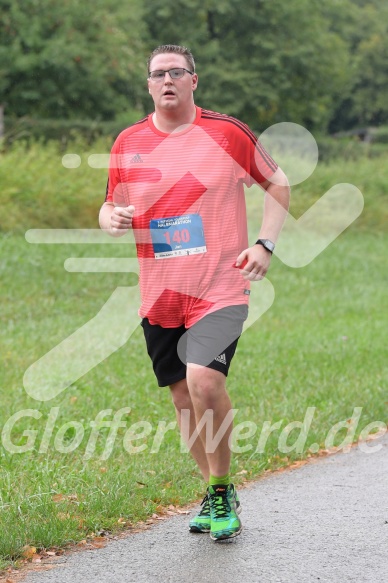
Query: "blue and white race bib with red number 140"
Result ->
[[150, 214, 206, 259]]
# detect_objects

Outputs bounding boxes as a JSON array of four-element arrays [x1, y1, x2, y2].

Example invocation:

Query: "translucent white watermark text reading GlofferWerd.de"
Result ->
[[1, 407, 387, 460]]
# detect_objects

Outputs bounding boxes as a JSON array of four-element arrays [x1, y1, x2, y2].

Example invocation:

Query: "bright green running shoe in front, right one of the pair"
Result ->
[[207, 484, 242, 541]]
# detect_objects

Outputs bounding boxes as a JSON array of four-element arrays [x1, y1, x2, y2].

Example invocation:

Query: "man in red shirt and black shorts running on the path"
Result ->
[[100, 45, 290, 541]]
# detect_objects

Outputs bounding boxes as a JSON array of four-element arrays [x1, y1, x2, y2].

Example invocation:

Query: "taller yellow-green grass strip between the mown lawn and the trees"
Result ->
[[0, 139, 388, 233]]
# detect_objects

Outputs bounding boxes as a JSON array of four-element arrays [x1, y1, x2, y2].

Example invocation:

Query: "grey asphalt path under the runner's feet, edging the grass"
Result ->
[[23, 435, 388, 583]]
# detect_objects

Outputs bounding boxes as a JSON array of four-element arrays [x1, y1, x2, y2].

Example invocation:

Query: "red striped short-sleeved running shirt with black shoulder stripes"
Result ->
[[105, 107, 277, 328]]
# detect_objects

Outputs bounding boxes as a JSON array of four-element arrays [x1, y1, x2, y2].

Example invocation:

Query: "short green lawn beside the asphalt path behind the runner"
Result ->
[[0, 144, 388, 568]]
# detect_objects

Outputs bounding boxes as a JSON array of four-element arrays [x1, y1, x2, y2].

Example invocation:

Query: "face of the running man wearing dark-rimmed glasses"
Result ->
[[148, 53, 198, 111]]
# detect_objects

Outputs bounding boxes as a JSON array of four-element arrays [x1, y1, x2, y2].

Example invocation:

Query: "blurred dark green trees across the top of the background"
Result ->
[[0, 0, 388, 131]]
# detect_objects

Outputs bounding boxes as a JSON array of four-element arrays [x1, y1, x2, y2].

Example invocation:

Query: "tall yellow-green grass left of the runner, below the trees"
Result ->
[[0, 138, 112, 232]]
